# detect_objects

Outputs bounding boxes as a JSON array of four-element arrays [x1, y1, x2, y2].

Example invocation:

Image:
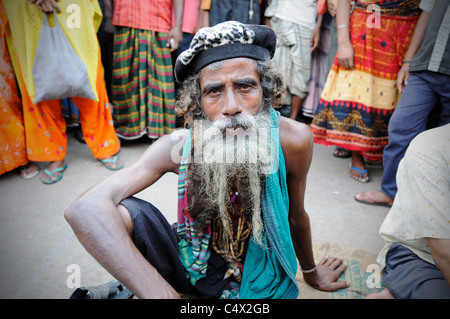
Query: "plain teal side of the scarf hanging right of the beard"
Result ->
[[240, 109, 299, 299]]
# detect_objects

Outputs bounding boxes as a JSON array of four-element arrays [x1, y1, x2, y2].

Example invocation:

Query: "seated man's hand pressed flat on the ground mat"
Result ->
[[303, 257, 350, 291]]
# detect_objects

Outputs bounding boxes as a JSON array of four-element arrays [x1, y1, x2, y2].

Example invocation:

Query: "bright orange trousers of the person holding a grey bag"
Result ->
[[14, 49, 120, 161]]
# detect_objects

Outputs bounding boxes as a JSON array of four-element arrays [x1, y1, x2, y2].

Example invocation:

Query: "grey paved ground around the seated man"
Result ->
[[0, 124, 388, 299]]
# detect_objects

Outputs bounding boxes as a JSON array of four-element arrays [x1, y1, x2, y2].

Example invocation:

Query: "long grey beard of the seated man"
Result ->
[[186, 113, 278, 247]]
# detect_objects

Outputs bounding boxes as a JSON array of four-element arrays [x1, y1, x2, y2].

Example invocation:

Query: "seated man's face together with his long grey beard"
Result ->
[[186, 58, 270, 246]]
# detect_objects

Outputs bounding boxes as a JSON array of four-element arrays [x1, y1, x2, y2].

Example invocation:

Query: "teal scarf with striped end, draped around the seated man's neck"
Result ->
[[178, 109, 298, 299]]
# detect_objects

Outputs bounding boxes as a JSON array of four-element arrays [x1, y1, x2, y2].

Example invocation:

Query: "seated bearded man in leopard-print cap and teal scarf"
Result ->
[[65, 21, 348, 298]]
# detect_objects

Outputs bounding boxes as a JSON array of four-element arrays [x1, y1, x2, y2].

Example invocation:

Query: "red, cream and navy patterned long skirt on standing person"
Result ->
[[310, 0, 419, 161]]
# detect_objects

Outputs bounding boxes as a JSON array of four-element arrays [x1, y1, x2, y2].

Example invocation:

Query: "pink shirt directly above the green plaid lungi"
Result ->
[[113, 0, 172, 33]]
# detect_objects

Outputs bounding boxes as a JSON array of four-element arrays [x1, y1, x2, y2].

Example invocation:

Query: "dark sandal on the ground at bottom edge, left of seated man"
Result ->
[[69, 280, 133, 299]]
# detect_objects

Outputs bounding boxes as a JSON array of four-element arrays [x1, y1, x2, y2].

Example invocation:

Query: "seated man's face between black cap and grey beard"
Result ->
[[200, 58, 263, 130]]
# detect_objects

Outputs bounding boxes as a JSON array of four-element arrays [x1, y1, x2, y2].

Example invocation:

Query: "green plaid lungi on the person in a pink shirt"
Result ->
[[112, 27, 175, 139]]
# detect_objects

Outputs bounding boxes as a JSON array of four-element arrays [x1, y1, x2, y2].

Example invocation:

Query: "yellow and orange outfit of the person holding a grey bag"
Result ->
[[3, 0, 120, 162]]
